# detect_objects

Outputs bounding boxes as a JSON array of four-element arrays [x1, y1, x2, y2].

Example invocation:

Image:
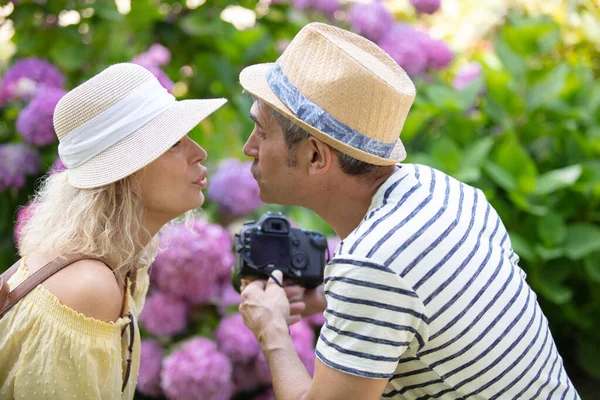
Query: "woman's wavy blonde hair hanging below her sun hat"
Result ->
[[17, 171, 158, 277]]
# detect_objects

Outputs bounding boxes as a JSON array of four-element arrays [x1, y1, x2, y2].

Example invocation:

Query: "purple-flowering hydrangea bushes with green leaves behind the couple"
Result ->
[[0, 0, 600, 400]]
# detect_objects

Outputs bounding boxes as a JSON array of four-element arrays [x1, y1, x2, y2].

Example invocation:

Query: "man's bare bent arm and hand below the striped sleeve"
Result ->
[[240, 271, 387, 400]]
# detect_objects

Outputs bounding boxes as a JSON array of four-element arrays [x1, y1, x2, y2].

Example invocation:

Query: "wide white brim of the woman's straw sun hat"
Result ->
[[68, 99, 227, 189]]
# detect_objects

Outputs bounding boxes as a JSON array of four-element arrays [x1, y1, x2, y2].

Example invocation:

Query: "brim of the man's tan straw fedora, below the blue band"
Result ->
[[240, 63, 406, 165]]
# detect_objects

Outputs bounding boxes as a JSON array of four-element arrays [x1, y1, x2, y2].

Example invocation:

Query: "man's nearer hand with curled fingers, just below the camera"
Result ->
[[239, 271, 296, 344]]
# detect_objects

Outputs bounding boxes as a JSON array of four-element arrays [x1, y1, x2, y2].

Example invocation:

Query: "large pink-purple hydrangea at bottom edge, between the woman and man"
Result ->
[[161, 337, 233, 400]]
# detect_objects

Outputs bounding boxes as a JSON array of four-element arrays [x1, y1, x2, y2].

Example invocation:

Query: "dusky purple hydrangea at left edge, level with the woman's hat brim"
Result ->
[[0, 143, 41, 192]]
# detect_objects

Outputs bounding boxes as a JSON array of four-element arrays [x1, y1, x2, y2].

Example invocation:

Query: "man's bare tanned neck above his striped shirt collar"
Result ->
[[307, 166, 396, 239]]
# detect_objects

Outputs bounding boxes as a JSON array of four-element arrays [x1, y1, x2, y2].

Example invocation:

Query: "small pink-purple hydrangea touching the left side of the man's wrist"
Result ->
[[215, 313, 260, 363]]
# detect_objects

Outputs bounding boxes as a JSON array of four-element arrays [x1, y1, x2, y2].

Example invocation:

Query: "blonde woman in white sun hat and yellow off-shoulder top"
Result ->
[[0, 64, 225, 399]]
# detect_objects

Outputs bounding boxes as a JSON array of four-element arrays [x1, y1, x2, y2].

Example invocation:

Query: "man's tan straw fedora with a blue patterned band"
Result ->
[[240, 23, 416, 165]]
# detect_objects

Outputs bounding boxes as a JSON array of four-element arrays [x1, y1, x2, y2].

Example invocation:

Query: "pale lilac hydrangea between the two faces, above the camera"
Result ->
[[208, 159, 262, 217]]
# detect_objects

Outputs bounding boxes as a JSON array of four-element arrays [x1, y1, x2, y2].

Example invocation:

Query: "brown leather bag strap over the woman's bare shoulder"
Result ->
[[0, 254, 110, 319]]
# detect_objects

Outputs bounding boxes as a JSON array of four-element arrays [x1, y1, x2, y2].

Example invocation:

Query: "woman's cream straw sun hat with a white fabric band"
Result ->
[[54, 63, 226, 188]]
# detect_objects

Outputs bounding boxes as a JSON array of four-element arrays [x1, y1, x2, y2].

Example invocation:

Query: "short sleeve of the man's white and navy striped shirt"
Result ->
[[316, 255, 429, 379]]
